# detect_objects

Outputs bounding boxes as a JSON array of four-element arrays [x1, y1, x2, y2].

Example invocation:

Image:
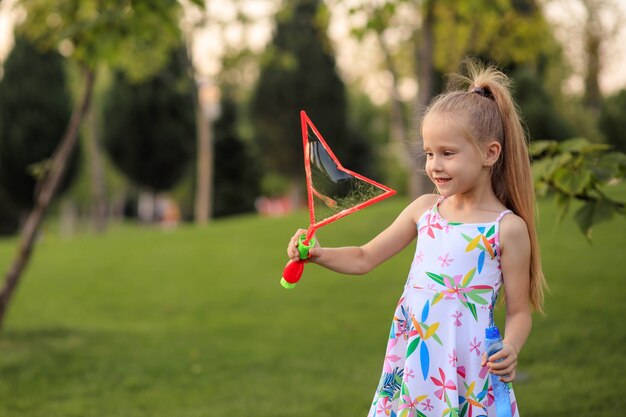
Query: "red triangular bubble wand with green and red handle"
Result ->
[[280, 111, 396, 288]]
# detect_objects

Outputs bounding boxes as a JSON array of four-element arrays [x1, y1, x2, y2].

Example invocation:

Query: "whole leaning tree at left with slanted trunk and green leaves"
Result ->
[[0, 0, 202, 327]]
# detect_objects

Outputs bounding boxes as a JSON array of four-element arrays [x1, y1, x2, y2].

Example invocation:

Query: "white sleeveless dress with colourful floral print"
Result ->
[[368, 198, 519, 417]]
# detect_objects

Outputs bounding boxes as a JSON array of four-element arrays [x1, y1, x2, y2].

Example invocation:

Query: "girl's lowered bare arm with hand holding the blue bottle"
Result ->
[[483, 215, 532, 382]]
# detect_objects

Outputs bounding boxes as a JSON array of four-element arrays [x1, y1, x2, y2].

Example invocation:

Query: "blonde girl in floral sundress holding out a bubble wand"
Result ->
[[287, 62, 544, 417]]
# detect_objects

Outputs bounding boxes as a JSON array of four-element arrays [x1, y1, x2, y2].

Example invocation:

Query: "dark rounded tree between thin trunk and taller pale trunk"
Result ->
[[103, 50, 195, 191]]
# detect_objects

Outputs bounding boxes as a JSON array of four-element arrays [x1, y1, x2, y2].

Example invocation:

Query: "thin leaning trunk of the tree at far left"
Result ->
[[0, 68, 95, 329]]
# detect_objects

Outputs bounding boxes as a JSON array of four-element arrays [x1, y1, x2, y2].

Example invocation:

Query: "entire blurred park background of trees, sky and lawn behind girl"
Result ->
[[0, 0, 626, 417]]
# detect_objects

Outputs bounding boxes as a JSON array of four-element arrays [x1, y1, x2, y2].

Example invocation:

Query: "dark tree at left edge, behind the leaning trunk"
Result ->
[[0, 36, 79, 209]]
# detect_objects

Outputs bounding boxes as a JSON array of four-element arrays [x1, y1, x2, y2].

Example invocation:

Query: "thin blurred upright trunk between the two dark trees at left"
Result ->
[[87, 91, 108, 233]]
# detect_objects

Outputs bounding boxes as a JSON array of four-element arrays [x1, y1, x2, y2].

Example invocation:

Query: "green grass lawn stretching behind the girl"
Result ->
[[0, 193, 626, 417]]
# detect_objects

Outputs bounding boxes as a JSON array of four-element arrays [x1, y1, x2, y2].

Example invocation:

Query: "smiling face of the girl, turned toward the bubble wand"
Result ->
[[422, 113, 489, 197]]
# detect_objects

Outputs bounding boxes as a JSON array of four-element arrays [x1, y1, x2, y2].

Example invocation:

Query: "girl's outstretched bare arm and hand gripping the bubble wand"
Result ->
[[287, 195, 436, 275]]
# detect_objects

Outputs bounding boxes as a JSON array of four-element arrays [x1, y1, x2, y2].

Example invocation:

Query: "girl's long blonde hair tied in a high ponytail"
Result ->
[[422, 59, 546, 312]]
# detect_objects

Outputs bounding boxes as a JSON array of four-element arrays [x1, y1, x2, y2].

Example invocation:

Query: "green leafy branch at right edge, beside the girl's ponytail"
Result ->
[[530, 138, 626, 240]]
